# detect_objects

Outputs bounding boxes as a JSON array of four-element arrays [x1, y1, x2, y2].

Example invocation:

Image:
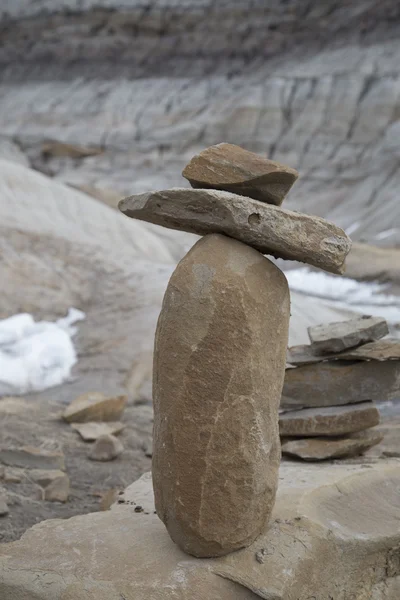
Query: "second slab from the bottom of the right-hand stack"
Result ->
[[279, 402, 379, 437]]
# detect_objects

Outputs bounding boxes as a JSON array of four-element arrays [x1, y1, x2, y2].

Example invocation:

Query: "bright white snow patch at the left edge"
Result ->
[[0, 308, 85, 396]]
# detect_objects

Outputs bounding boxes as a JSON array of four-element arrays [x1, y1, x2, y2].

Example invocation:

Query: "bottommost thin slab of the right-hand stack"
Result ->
[[282, 430, 383, 461]]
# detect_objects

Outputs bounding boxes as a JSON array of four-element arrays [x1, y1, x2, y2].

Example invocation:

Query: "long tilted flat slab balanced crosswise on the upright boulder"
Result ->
[[118, 188, 351, 273]]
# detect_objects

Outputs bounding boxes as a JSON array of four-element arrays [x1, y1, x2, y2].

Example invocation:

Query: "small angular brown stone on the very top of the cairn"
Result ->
[[182, 144, 299, 206]]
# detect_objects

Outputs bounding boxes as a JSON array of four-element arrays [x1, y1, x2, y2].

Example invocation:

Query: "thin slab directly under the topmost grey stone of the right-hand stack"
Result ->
[[287, 340, 400, 366]]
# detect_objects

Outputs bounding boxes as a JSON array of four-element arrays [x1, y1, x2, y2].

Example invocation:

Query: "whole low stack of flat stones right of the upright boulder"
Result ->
[[279, 316, 400, 461]]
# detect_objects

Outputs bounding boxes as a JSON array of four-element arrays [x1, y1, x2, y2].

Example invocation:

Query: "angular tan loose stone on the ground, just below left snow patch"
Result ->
[[63, 392, 128, 423]]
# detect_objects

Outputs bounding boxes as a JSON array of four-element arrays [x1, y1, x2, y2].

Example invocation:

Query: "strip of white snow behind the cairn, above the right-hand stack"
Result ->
[[285, 267, 400, 325]]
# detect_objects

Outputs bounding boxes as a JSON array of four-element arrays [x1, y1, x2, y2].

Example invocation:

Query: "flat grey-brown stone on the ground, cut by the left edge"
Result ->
[[0, 446, 65, 471]]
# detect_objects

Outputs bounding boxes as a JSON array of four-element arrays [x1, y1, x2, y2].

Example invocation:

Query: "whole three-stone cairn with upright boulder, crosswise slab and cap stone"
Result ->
[[119, 144, 351, 557]]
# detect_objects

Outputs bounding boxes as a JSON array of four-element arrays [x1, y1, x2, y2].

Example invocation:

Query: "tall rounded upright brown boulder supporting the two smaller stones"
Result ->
[[153, 234, 290, 557]]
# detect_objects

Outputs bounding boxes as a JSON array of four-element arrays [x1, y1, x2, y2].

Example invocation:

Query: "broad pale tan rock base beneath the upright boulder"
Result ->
[[0, 459, 400, 600]]
